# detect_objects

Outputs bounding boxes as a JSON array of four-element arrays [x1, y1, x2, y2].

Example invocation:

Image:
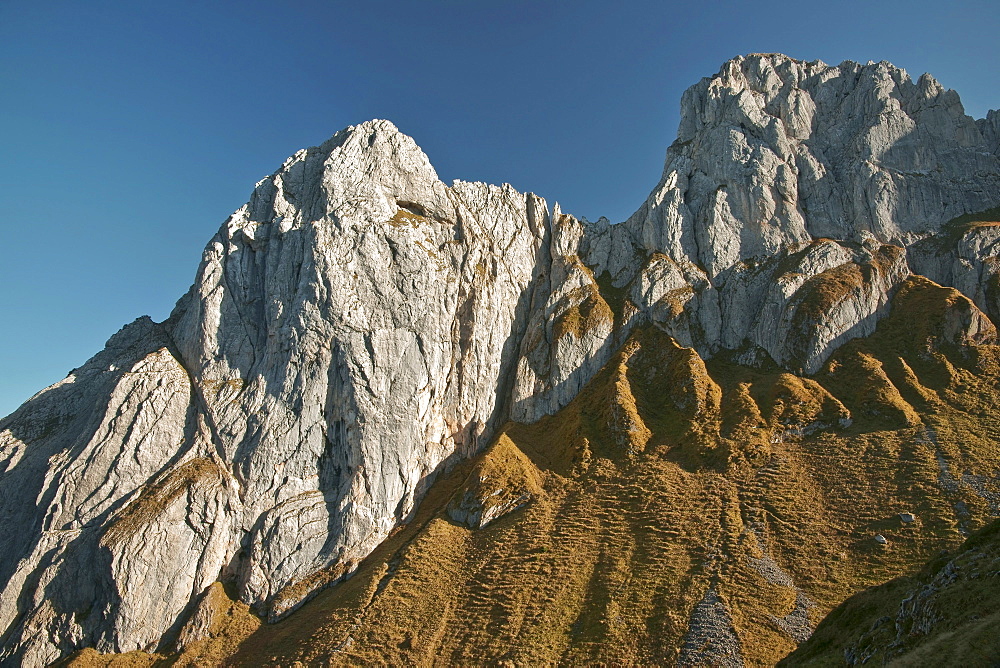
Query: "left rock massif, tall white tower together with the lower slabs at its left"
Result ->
[[0, 121, 550, 664]]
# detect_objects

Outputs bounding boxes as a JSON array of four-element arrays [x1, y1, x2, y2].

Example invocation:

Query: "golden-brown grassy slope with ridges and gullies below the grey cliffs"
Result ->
[[64, 279, 1000, 665]]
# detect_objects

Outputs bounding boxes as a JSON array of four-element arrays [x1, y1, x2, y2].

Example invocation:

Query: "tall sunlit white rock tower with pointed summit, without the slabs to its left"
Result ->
[[168, 122, 548, 624]]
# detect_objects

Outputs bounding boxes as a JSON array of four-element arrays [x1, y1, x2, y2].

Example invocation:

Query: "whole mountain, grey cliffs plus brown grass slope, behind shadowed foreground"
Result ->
[[0, 54, 1000, 666]]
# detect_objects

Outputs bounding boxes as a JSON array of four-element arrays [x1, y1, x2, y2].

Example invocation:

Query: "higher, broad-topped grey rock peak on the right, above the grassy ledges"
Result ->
[[630, 54, 1000, 276]]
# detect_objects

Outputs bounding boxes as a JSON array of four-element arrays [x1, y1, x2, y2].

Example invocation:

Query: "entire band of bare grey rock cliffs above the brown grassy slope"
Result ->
[[0, 55, 1000, 665]]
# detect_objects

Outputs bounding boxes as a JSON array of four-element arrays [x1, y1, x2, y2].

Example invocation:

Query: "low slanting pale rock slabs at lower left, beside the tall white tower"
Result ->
[[0, 318, 216, 665]]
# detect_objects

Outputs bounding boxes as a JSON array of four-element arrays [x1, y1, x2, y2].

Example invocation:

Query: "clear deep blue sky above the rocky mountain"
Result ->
[[0, 0, 1000, 415]]
